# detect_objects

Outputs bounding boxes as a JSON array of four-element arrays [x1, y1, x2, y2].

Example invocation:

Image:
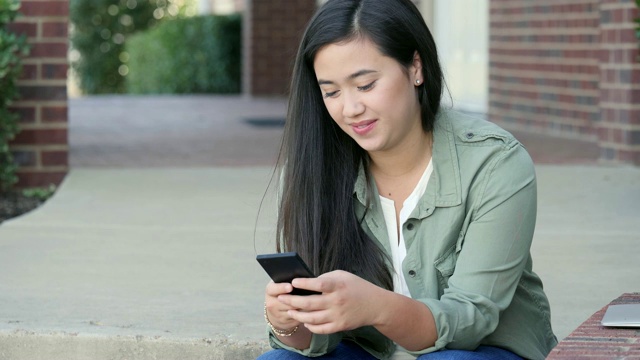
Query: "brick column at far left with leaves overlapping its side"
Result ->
[[10, 0, 69, 187]]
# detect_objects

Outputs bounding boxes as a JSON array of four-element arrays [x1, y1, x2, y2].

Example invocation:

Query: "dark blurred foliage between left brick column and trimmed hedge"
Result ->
[[69, 0, 195, 94]]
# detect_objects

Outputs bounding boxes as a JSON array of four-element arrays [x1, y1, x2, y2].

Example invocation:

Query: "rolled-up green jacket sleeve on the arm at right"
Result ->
[[415, 143, 537, 354]]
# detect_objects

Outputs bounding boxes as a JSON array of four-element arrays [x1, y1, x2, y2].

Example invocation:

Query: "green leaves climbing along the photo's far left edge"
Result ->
[[0, 0, 29, 193]]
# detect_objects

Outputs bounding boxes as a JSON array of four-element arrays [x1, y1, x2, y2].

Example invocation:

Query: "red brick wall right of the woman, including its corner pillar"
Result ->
[[489, 0, 640, 164]]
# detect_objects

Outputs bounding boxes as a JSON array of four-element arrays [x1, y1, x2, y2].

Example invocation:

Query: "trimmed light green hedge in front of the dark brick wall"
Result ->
[[126, 14, 242, 94]]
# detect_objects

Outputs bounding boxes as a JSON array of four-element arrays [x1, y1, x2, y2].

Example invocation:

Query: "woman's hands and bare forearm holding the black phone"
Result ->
[[267, 270, 438, 351]]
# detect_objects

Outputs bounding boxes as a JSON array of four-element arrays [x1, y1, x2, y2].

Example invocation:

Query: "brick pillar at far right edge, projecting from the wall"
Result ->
[[597, 0, 640, 165]]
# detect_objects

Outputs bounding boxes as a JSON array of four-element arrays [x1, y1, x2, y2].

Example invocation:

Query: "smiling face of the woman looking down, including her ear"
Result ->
[[313, 39, 424, 155]]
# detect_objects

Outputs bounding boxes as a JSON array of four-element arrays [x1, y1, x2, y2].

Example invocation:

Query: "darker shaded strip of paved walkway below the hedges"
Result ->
[[69, 96, 286, 168]]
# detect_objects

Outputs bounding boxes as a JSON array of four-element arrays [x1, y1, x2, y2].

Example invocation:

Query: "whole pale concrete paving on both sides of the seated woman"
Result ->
[[0, 97, 640, 360]]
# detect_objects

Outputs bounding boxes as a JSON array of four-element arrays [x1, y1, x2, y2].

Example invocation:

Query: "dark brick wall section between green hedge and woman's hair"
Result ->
[[246, 0, 316, 96]]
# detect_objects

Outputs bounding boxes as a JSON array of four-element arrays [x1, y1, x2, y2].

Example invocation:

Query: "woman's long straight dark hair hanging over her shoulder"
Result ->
[[277, 0, 443, 289]]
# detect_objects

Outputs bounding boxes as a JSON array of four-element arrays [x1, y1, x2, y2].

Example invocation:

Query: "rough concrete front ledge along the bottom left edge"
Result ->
[[0, 330, 268, 360]]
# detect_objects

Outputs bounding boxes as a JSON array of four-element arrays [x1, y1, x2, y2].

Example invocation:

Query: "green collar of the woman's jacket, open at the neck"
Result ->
[[354, 109, 462, 212]]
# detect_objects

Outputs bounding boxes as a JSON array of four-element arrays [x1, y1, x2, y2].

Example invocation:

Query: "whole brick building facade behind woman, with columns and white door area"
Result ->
[[6, 0, 640, 187]]
